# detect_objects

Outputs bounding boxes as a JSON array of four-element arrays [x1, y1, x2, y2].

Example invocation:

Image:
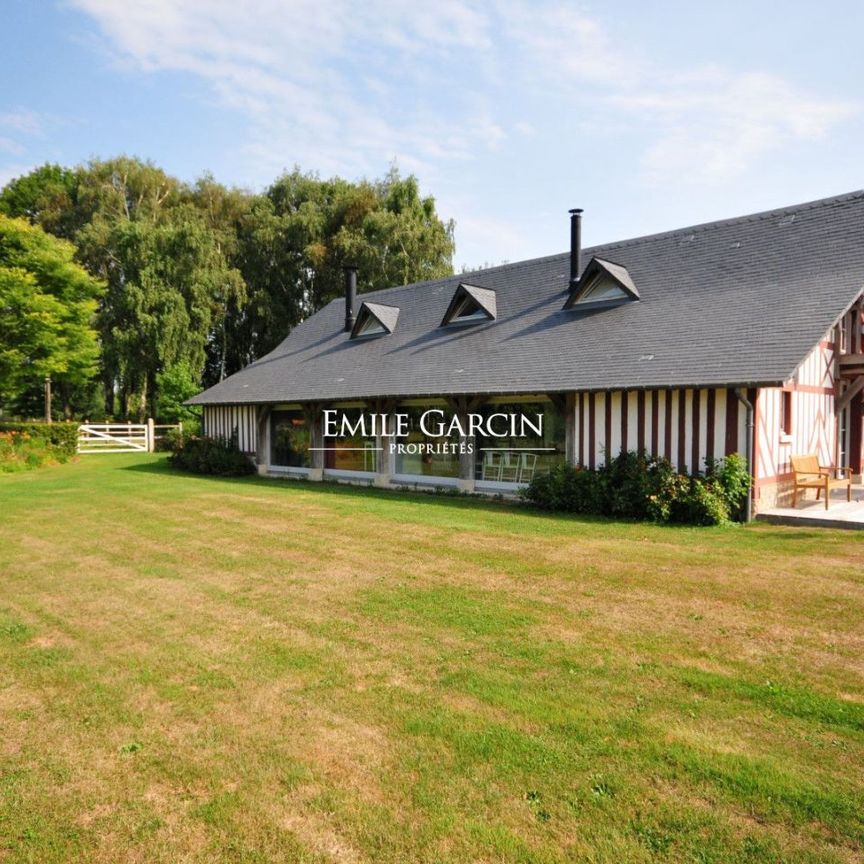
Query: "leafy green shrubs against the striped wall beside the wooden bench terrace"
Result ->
[[520, 451, 750, 525]]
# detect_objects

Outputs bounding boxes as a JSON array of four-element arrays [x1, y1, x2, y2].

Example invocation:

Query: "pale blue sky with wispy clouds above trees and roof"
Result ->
[[0, 0, 864, 269]]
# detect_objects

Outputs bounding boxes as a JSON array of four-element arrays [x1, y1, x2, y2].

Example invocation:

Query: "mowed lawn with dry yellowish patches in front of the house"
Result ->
[[0, 456, 864, 864]]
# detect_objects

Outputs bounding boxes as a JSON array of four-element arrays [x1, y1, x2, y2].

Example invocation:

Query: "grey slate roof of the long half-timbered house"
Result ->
[[190, 191, 864, 405]]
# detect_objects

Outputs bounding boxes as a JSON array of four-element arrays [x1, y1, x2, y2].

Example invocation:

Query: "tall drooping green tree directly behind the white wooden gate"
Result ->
[[77, 157, 245, 417]]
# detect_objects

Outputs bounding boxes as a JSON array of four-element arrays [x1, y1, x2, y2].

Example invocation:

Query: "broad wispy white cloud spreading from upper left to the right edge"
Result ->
[[68, 0, 860, 197]]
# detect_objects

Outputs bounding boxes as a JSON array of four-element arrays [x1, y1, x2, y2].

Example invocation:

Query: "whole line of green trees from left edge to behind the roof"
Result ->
[[0, 157, 454, 421]]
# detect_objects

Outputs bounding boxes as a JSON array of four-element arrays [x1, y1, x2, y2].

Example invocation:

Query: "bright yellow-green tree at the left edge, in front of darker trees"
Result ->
[[0, 216, 103, 414]]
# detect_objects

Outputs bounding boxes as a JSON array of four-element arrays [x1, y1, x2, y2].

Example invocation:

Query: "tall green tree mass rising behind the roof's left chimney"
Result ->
[[217, 168, 454, 380]]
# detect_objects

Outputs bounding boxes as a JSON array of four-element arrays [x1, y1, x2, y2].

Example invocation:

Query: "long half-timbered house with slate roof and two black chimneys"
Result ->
[[191, 192, 864, 508]]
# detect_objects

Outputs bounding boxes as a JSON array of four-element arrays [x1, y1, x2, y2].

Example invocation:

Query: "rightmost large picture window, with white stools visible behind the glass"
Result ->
[[474, 399, 566, 483]]
